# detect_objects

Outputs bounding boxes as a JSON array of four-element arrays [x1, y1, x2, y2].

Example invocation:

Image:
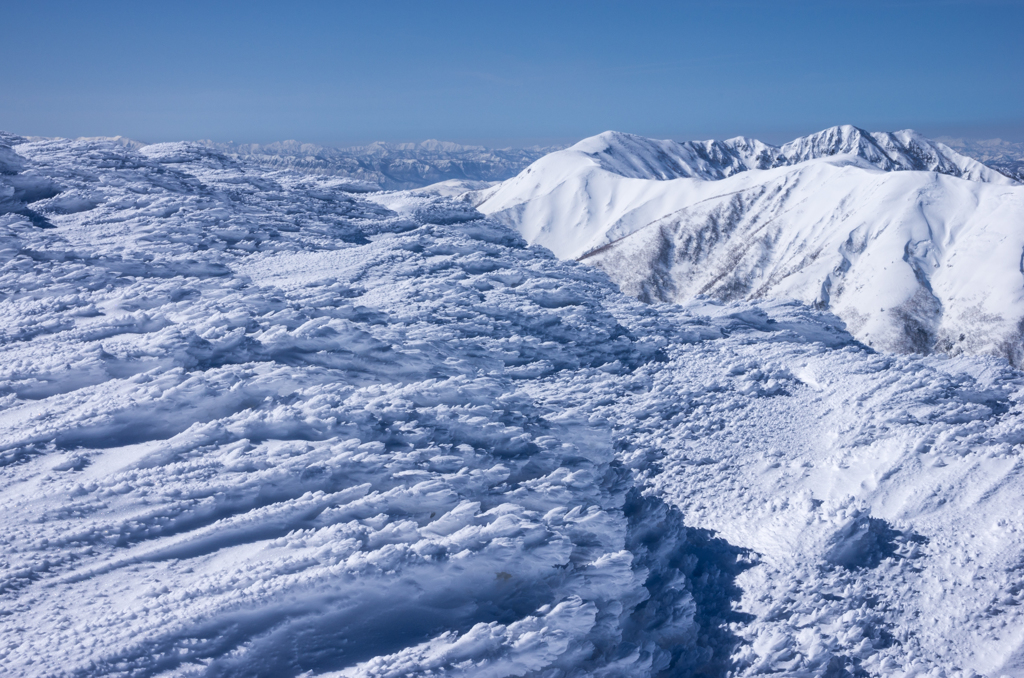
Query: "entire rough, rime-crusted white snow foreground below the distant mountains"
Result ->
[[0, 136, 1024, 678]]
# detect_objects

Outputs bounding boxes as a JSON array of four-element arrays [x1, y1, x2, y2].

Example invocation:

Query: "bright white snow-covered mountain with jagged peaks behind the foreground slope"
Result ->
[[474, 126, 1024, 365]]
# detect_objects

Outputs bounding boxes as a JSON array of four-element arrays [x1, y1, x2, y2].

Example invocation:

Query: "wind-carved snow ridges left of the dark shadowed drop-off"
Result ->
[[0, 135, 735, 676]]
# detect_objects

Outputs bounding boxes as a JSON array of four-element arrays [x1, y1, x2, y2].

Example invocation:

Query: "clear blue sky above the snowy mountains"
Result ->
[[0, 0, 1024, 144]]
